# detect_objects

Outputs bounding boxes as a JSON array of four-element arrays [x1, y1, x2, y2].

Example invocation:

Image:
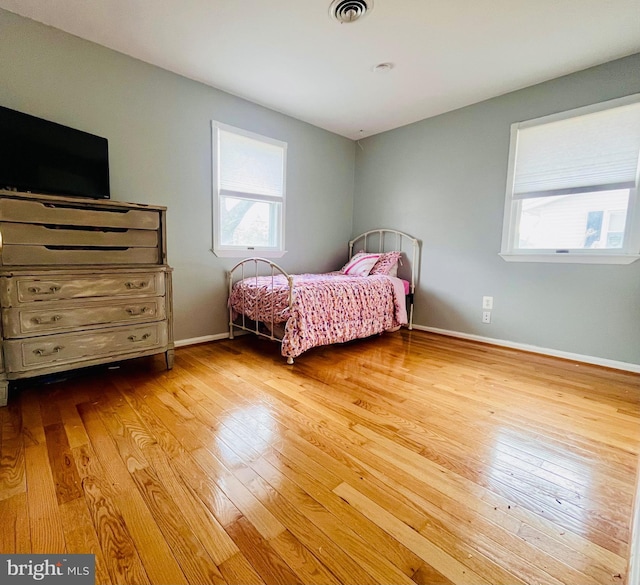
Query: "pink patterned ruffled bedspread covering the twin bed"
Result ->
[[229, 272, 407, 357]]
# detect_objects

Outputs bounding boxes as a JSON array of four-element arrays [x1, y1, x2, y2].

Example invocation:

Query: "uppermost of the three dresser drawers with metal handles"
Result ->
[[0, 270, 165, 307]]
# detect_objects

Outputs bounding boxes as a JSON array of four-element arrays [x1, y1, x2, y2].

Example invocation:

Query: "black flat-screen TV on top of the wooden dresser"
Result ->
[[0, 106, 110, 199]]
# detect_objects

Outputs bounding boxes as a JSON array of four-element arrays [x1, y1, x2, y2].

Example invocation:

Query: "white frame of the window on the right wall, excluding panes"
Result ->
[[499, 94, 640, 264]]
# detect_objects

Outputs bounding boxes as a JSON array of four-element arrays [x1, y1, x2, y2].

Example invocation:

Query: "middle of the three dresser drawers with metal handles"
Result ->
[[2, 297, 166, 338]]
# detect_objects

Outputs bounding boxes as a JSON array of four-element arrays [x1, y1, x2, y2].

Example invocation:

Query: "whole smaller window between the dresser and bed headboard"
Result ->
[[211, 121, 287, 257]]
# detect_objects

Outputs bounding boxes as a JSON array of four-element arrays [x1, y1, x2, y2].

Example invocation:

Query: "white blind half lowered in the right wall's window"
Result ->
[[513, 103, 640, 199]]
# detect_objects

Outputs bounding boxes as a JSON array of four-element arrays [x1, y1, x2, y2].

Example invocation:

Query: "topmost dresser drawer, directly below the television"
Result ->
[[0, 197, 160, 230]]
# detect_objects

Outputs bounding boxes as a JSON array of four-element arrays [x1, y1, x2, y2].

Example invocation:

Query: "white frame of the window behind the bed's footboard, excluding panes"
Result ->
[[211, 120, 288, 258]]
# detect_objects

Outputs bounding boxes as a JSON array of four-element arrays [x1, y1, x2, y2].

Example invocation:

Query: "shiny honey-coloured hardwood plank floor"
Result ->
[[0, 330, 640, 585]]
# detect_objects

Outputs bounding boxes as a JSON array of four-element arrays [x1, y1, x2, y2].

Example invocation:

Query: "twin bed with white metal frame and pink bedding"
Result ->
[[228, 229, 420, 364]]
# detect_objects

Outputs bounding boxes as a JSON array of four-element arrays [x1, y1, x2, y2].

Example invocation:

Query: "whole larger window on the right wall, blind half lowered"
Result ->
[[500, 94, 640, 264]]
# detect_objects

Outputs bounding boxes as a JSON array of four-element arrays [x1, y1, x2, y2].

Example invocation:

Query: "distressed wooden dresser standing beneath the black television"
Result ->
[[0, 190, 173, 406]]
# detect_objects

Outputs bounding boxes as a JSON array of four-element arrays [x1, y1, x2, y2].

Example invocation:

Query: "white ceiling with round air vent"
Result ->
[[0, 0, 640, 139]]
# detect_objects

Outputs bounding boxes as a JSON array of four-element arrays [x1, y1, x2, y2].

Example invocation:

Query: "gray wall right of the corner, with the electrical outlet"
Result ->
[[353, 55, 640, 364]]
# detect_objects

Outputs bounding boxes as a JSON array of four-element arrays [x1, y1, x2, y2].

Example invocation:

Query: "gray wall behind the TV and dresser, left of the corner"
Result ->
[[0, 10, 355, 340]]
